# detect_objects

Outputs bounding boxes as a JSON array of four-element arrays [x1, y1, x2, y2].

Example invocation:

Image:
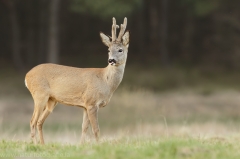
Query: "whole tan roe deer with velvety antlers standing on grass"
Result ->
[[25, 18, 130, 144]]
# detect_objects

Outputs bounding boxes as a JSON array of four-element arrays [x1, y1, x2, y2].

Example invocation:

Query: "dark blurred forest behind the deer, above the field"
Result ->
[[0, 0, 240, 71]]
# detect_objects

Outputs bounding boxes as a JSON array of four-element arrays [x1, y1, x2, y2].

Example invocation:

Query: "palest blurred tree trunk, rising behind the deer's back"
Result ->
[[47, 0, 60, 63]]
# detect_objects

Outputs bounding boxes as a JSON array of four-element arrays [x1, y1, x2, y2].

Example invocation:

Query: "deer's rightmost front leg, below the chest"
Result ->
[[87, 106, 100, 142]]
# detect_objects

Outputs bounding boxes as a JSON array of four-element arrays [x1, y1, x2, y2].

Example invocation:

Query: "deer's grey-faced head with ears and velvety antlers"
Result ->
[[100, 18, 130, 66]]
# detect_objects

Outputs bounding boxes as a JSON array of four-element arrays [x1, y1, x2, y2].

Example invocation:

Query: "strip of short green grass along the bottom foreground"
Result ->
[[0, 137, 240, 159]]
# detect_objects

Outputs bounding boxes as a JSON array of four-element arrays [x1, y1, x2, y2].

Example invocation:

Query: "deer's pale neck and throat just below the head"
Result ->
[[105, 63, 125, 92]]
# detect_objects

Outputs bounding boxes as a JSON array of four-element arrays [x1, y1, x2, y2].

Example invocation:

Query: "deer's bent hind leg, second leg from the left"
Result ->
[[37, 98, 57, 144]]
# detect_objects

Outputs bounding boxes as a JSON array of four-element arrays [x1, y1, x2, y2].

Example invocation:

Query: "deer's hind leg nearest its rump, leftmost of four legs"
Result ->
[[30, 96, 49, 144]]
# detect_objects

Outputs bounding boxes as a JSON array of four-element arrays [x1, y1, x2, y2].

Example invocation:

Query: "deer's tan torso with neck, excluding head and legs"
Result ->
[[26, 64, 124, 108]]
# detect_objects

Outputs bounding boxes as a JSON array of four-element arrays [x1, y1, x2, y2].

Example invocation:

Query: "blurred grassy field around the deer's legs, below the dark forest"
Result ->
[[0, 68, 240, 159]]
